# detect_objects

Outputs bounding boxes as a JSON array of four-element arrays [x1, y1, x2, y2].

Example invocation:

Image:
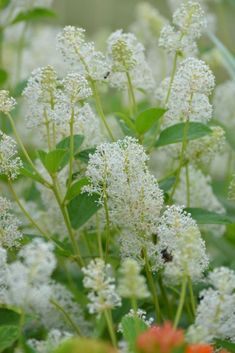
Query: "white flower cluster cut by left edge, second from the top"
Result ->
[[0, 131, 22, 179]]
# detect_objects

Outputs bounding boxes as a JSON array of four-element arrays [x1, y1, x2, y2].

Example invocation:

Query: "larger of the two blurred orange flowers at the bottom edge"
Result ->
[[137, 321, 185, 353]]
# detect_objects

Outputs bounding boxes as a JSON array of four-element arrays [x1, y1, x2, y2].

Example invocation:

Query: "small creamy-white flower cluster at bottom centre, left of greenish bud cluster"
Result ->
[[82, 258, 121, 314]]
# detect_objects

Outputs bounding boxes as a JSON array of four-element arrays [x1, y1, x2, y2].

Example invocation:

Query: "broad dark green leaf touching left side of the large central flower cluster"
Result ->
[[68, 193, 101, 229]]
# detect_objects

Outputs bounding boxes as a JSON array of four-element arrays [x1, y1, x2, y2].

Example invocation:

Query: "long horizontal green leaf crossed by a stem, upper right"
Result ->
[[155, 122, 212, 147]]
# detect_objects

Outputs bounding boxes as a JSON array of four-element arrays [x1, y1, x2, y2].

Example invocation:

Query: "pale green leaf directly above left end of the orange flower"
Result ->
[[121, 316, 148, 352]]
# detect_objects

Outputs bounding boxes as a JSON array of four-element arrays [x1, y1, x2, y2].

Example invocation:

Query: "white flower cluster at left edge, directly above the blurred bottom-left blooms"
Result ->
[[0, 197, 22, 248]]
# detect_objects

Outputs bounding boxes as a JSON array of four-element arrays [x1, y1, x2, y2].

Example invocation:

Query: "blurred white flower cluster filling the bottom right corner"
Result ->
[[188, 267, 235, 343]]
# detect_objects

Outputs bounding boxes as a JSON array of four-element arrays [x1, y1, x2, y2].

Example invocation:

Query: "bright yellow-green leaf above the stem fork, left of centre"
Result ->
[[38, 149, 67, 174]]
